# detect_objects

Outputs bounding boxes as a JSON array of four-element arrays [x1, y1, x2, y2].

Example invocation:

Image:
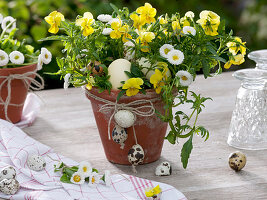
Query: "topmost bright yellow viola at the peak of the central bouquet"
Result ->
[[136, 3, 157, 24]]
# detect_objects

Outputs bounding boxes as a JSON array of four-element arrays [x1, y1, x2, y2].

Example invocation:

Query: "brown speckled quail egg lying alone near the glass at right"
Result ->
[[229, 151, 247, 172]]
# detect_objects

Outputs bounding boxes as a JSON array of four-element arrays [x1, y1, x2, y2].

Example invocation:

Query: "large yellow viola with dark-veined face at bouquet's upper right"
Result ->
[[197, 10, 220, 36]]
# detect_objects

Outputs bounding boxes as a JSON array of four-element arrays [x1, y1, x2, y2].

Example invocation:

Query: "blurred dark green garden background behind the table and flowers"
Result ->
[[0, 0, 267, 89]]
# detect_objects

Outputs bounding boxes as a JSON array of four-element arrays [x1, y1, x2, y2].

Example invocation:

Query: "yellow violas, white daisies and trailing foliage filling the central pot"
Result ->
[[43, 3, 249, 168]]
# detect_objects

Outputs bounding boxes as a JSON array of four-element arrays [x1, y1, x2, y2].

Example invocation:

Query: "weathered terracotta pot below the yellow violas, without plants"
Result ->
[[86, 88, 168, 165]]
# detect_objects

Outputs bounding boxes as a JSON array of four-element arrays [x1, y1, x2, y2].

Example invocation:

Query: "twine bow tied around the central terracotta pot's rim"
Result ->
[[82, 87, 159, 144]]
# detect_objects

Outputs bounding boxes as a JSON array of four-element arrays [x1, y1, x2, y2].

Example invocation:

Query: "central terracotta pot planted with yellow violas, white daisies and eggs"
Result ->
[[44, 3, 246, 168]]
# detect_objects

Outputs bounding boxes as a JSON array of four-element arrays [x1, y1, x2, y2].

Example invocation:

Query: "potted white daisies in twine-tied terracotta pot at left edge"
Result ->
[[0, 14, 52, 123]]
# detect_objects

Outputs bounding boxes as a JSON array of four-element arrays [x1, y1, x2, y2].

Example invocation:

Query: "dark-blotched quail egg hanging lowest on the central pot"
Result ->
[[128, 144, 145, 165]]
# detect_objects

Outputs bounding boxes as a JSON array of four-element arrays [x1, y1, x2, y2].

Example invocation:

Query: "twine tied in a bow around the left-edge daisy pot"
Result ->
[[0, 70, 44, 122]]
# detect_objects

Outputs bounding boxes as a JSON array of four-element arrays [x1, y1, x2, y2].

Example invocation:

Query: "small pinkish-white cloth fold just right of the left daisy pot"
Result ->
[[16, 93, 42, 128]]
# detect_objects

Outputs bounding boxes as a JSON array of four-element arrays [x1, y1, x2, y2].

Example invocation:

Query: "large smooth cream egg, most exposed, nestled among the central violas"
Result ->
[[108, 59, 131, 90]]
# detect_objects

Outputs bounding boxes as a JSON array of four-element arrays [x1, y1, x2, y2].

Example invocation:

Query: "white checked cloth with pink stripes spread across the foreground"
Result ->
[[0, 120, 186, 200]]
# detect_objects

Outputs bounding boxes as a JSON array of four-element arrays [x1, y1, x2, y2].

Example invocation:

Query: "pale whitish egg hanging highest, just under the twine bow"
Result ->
[[114, 110, 135, 128]]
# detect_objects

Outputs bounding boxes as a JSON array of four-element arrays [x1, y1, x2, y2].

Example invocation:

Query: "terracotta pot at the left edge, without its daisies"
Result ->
[[0, 64, 36, 123]]
